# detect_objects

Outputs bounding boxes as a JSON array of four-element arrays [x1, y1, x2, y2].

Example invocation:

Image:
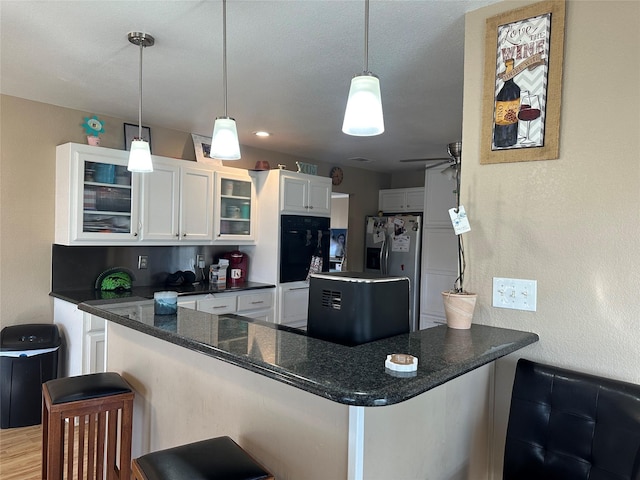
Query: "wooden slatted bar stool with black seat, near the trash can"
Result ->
[[42, 372, 134, 480]]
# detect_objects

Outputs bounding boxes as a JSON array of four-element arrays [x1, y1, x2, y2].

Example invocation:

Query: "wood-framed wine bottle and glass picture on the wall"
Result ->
[[480, 0, 565, 164]]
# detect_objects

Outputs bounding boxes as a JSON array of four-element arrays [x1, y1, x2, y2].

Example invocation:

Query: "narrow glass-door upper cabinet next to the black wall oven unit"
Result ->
[[213, 168, 256, 244]]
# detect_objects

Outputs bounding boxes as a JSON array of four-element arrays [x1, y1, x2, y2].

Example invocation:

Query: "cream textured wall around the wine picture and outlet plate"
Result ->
[[461, 1, 640, 476]]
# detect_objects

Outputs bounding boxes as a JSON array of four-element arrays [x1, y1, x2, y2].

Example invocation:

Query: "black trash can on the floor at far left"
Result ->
[[0, 323, 62, 428]]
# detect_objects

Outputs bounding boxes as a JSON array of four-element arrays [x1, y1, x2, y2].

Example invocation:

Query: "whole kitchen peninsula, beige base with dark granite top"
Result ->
[[78, 298, 538, 480]]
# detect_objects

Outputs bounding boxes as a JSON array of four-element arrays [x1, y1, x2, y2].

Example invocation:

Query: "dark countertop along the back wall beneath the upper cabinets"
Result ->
[[49, 282, 275, 304]]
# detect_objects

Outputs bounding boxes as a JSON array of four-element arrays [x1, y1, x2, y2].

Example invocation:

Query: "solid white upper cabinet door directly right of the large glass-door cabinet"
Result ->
[[142, 161, 180, 241]]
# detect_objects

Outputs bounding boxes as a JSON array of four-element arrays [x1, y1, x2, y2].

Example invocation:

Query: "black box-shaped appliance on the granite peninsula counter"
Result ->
[[307, 272, 410, 346]]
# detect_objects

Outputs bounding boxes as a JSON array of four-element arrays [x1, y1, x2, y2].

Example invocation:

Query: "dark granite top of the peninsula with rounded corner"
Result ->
[[78, 298, 538, 406]]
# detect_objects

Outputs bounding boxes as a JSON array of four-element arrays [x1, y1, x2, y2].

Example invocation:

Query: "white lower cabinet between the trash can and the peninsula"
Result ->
[[53, 298, 107, 376]]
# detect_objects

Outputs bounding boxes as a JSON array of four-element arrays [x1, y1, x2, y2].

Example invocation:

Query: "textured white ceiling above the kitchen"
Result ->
[[0, 0, 495, 171]]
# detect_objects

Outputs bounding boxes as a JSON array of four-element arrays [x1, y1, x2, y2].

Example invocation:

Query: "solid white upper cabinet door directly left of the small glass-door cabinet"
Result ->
[[180, 167, 213, 241]]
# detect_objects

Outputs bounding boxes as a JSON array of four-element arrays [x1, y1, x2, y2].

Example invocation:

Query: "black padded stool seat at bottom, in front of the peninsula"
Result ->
[[132, 437, 274, 480]]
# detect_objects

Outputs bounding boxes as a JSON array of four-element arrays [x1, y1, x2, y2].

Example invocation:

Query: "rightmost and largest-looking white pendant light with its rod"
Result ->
[[342, 0, 384, 137]]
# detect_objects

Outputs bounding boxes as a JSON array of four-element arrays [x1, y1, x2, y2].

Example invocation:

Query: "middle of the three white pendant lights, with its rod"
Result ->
[[210, 0, 240, 160]]
